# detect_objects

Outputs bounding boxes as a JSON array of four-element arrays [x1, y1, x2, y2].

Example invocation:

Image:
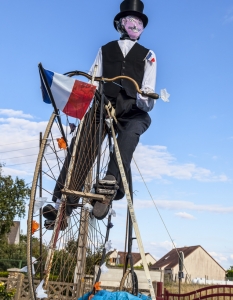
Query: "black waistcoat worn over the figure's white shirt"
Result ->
[[102, 41, 149, 99]]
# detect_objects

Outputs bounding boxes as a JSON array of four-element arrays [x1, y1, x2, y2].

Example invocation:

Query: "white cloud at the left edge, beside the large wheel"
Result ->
[[0, 115, 51, 181]]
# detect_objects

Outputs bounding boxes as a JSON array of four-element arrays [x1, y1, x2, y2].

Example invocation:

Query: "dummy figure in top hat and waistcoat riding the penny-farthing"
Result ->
[[43, 0, 156, 224]]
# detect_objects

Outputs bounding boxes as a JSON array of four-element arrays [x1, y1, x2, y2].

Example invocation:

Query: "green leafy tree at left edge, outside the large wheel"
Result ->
[[0, 164, 30, 239]]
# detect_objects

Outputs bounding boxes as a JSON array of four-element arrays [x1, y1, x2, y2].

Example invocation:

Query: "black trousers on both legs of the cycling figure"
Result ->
[[52, 90, 151, 215]]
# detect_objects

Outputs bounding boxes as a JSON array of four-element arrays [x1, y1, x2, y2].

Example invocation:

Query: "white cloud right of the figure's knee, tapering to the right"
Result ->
[[132, 143, 228, 182]]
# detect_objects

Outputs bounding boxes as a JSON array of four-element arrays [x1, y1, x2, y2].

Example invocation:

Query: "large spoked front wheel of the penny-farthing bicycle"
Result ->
[[27, 90, 111, 300]]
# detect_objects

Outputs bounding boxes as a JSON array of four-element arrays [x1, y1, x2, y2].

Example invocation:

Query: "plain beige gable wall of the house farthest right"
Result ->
[[173, 247, 225, 280]]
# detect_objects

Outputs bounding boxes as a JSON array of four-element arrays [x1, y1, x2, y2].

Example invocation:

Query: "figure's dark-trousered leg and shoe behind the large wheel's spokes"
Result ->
[[43, 93, 106, 220]]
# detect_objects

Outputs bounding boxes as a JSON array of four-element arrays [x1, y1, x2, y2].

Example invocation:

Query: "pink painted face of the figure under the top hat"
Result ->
[[121, 16, 144, 40]]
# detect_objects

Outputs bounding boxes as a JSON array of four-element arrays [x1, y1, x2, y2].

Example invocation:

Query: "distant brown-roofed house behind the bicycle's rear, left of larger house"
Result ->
[[107, 249, 156, 267]]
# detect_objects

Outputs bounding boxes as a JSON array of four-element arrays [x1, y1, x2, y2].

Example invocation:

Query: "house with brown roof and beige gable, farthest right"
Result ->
[[151, 245, 226, 280]]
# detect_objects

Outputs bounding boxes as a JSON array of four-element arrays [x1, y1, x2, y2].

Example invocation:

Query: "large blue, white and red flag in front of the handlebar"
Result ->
[[41, 69, 96, 120]]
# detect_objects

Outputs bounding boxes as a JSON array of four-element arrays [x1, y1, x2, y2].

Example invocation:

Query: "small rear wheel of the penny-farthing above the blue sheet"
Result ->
[[120, 269, 138, 295]]
